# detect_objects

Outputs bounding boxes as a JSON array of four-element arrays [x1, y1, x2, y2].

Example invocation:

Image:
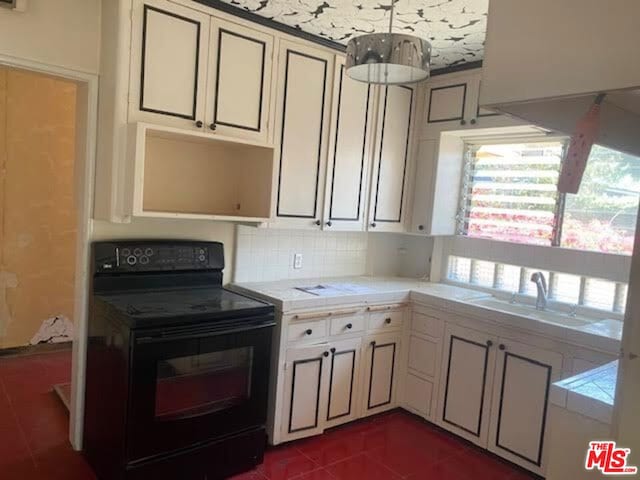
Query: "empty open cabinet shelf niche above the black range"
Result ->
[[132, 123, 273, 222]]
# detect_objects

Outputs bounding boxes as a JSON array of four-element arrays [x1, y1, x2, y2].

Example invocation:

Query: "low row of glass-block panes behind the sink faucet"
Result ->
[[447, 255, 628, 313]]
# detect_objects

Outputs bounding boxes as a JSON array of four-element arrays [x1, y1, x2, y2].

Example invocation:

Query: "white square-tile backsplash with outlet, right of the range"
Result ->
[[234, 225, 367, 282]]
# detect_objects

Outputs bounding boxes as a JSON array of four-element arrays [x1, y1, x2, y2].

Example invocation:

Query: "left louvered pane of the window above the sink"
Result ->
[[459, 142, 564, 245]]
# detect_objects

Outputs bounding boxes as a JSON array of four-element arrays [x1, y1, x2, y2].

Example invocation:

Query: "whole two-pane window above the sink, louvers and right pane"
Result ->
[[458, 141, 640, 255]]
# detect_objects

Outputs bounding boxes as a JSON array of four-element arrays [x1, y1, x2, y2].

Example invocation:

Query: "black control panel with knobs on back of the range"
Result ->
[[93, 241, 224, 273]]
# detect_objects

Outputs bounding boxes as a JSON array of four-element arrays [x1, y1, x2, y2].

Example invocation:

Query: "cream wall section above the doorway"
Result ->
[[0, 0, 101, 73]]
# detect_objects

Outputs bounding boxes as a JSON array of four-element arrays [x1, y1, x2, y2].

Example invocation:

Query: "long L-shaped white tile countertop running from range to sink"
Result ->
[[230, 276, 622, 355]]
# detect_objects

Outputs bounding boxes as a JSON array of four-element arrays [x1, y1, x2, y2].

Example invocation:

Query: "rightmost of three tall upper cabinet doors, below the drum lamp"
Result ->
[[368, 85, 414, 232]]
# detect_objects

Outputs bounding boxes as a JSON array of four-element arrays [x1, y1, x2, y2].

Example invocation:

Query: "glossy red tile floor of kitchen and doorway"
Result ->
[[0, 351, 535, 480]]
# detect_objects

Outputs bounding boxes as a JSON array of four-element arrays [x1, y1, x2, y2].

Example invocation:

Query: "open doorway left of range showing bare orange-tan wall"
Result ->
[[0, 66, 81, 471]]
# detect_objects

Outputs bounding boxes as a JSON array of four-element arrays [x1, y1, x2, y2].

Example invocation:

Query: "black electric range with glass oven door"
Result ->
[[84, 241, 275, 480]]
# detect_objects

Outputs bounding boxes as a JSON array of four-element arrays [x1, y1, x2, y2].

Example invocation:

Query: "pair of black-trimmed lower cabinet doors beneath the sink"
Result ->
[[437, 318, 564, 475]]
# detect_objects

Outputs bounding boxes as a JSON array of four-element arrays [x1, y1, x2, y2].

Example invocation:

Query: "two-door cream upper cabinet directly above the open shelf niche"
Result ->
[[129, 0, 273, 143]]
